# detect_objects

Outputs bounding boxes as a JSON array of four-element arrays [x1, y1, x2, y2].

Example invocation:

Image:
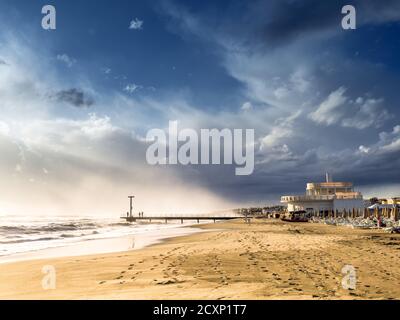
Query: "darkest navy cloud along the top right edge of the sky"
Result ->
[[241, 0, 400, 46]]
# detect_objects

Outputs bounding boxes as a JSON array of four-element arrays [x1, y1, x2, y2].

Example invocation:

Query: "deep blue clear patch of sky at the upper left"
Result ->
[[2, 1, 240, 107]]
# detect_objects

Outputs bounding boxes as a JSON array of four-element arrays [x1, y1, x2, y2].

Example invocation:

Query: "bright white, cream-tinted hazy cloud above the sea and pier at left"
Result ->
[[0, 35, 239, 216]]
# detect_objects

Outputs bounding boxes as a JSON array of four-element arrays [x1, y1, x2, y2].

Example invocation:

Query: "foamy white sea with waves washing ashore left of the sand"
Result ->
[[0, 215, 200, 263]]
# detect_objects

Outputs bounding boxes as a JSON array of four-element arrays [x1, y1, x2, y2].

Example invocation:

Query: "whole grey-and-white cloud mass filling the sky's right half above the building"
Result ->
[[159, 0, 400, 203]]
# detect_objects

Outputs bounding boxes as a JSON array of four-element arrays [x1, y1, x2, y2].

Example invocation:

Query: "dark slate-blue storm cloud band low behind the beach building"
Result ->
[[180, 141, 400, 203]]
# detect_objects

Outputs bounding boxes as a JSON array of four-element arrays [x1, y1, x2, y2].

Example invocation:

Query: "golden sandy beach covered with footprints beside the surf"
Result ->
[[0, 220, 400, 299]]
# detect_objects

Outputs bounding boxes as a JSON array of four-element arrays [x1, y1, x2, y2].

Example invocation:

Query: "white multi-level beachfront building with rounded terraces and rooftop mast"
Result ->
[[281, 174, 364, 213]]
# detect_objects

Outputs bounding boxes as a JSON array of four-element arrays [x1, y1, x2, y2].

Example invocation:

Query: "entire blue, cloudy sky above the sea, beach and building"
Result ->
[[0, 0, 400, 215]]
